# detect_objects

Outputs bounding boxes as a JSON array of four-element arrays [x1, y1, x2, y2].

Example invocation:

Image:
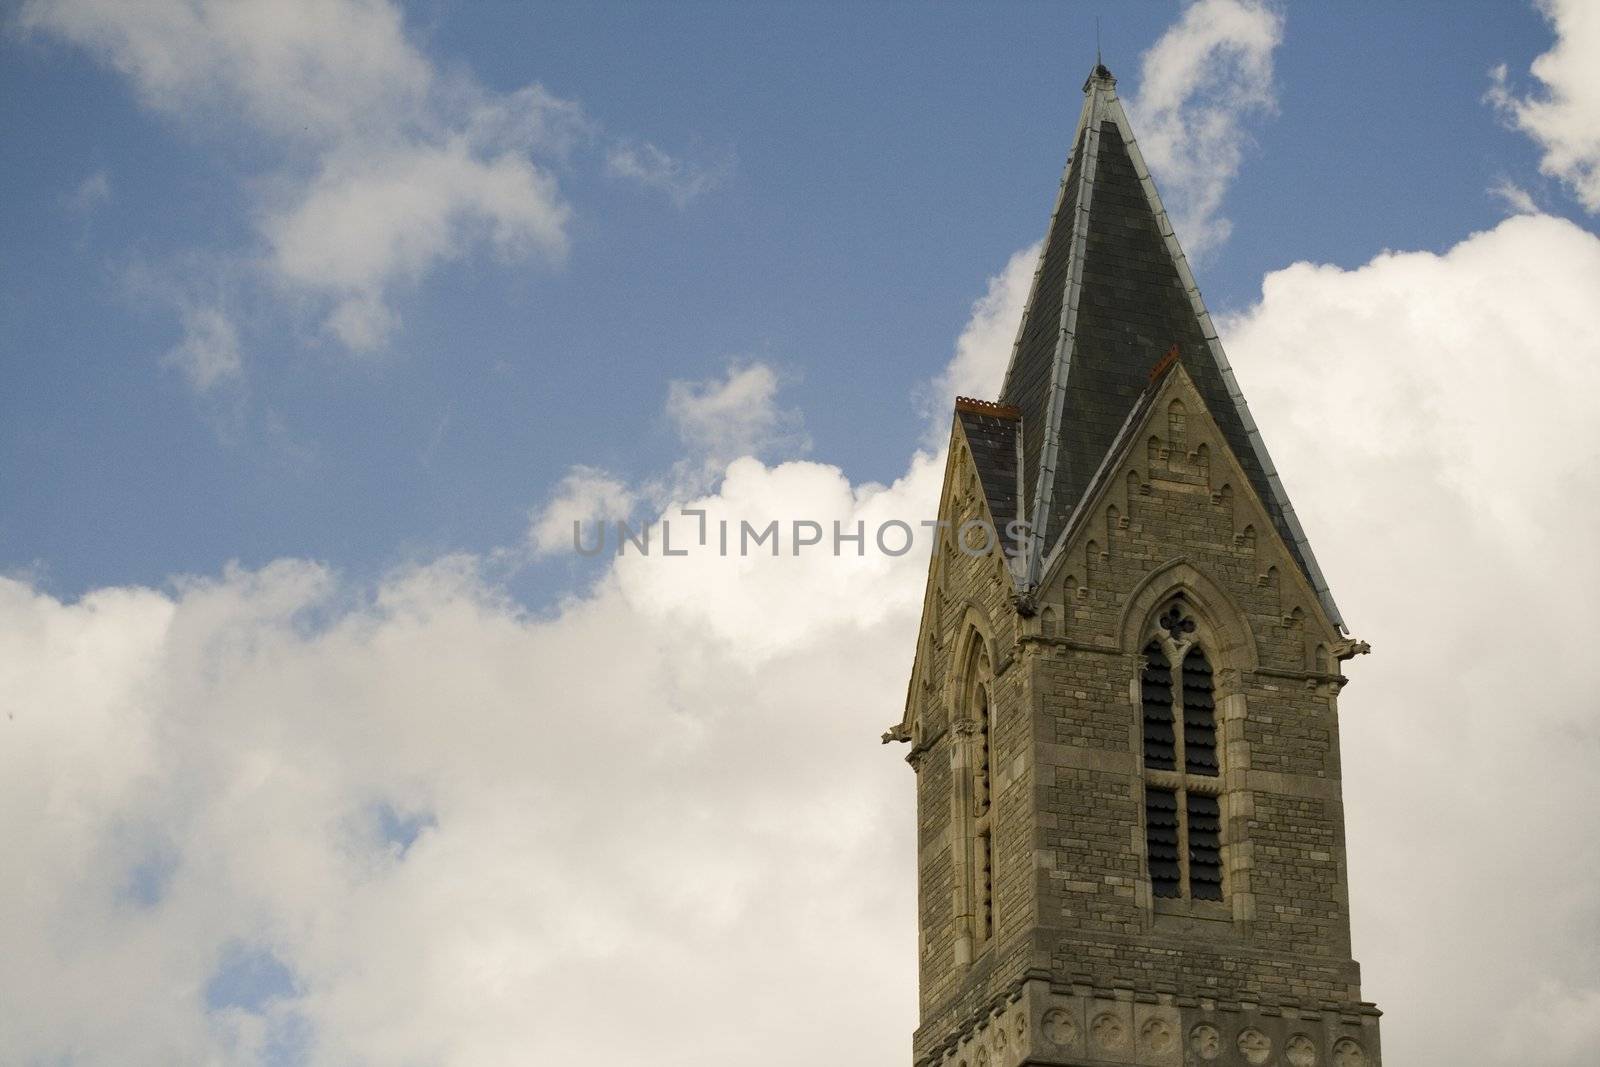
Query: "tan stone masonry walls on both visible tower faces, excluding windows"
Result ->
[[910, 368, 1378, 1067]]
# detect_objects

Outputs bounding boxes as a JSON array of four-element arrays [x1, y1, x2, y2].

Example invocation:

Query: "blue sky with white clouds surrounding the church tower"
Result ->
[[0, 0, 1600, 1067]]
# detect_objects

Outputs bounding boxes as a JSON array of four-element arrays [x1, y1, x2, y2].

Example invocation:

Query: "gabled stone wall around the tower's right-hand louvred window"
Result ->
[[1024, 373, 1358, 1006]]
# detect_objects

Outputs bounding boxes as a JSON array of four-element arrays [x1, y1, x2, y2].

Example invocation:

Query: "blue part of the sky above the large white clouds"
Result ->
[[0, 3, 1573, 600]]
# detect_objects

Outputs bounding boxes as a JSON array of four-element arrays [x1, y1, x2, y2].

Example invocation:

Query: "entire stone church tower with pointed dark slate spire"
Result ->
[[885, 66, 1379, 1067]]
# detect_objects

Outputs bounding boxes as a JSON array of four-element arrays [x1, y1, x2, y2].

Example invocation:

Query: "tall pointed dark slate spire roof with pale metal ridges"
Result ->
[[1000, 66, 1344, 629]]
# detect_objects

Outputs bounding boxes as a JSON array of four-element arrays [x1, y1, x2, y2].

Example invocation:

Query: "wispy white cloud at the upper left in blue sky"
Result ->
[[21, 0, 589, 358]]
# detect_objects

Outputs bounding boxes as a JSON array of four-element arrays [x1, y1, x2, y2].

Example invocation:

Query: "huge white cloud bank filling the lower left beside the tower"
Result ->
[[0, 461, 938, 1065]]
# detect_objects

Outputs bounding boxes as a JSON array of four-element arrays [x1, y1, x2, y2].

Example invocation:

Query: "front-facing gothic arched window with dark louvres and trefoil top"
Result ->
[[1139, 601, 1222, 901]]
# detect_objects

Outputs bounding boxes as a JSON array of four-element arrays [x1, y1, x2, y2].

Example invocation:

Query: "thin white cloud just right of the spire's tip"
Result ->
[[1128, 0, 1283, 258]]
